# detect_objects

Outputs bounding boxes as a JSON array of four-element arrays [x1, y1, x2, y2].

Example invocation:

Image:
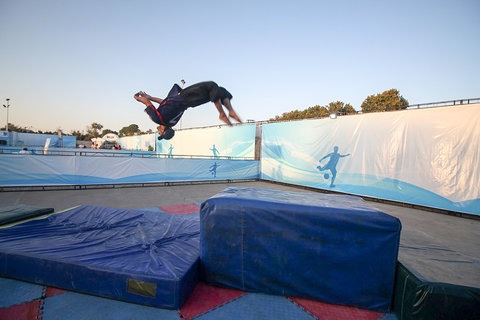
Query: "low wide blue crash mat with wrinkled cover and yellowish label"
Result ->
[[0, 206, 200, 308]]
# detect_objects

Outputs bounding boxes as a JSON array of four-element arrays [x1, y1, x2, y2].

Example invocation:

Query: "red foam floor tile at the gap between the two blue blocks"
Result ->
[[179, 282, 247, 320]]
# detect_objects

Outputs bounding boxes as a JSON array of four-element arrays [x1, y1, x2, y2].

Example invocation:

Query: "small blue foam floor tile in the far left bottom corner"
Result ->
[[0, 278, 43, 308]]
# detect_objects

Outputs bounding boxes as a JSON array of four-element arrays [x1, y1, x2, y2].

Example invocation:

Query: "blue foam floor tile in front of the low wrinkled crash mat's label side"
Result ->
[[43, 292, 180, 320]]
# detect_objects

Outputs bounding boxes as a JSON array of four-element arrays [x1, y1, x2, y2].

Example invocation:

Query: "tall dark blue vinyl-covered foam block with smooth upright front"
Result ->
[[200, 188, 401, 311]]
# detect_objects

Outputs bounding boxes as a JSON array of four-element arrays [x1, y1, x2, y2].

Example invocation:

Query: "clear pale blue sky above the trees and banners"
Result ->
[[0, 0, 480, 133]]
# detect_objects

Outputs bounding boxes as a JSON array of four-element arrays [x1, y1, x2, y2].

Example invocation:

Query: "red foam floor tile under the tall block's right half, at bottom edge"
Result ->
[[287, 297, 385, 320]]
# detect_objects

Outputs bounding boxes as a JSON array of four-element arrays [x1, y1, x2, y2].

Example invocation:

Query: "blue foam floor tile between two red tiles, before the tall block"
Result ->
[[198, 293, 313, 320]]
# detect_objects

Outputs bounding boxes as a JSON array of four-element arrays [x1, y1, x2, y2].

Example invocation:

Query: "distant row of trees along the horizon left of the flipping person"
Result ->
[[1, 122, 153, 141]]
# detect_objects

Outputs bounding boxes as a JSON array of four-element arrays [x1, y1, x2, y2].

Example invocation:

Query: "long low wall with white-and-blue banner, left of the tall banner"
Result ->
[[0, 154, 259, 187]]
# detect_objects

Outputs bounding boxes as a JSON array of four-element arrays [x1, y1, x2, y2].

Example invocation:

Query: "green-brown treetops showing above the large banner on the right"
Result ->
[[270, 89, 408, 121]]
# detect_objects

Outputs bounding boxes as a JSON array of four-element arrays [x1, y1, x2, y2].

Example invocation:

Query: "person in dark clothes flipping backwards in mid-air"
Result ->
[[133, 80, 242, 140]]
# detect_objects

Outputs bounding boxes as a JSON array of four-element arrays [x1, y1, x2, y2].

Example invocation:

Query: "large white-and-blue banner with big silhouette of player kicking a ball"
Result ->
[[261, 104, 480, 214]]
